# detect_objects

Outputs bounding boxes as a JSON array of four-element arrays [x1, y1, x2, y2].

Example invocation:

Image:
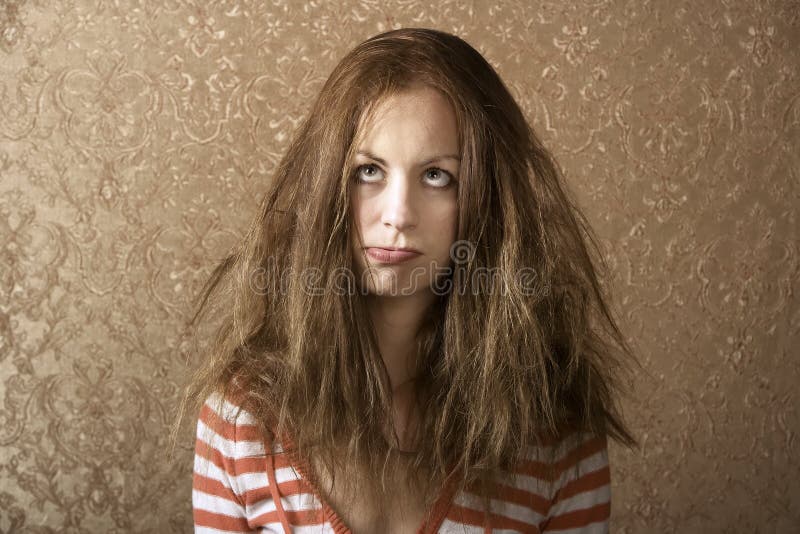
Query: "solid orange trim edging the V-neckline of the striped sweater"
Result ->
[[276, 436, 458, 534]]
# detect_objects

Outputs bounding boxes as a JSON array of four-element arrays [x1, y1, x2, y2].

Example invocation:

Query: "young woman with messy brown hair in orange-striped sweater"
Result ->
[[182, 28, 636, 534]]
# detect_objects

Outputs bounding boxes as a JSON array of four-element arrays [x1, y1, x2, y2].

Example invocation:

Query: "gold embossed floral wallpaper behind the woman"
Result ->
[[0, 0, 800, 534]]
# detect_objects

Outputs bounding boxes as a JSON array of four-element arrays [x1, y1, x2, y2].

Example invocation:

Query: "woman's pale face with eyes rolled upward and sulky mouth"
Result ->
[[352, 87, 460, 296]]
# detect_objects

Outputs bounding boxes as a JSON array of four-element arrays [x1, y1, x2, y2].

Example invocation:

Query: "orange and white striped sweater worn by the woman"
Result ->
[[192, 396, 611, 534]]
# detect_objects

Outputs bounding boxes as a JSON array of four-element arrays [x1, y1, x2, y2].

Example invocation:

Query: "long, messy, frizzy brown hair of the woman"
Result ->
[[176, 28, 637, 520]]
